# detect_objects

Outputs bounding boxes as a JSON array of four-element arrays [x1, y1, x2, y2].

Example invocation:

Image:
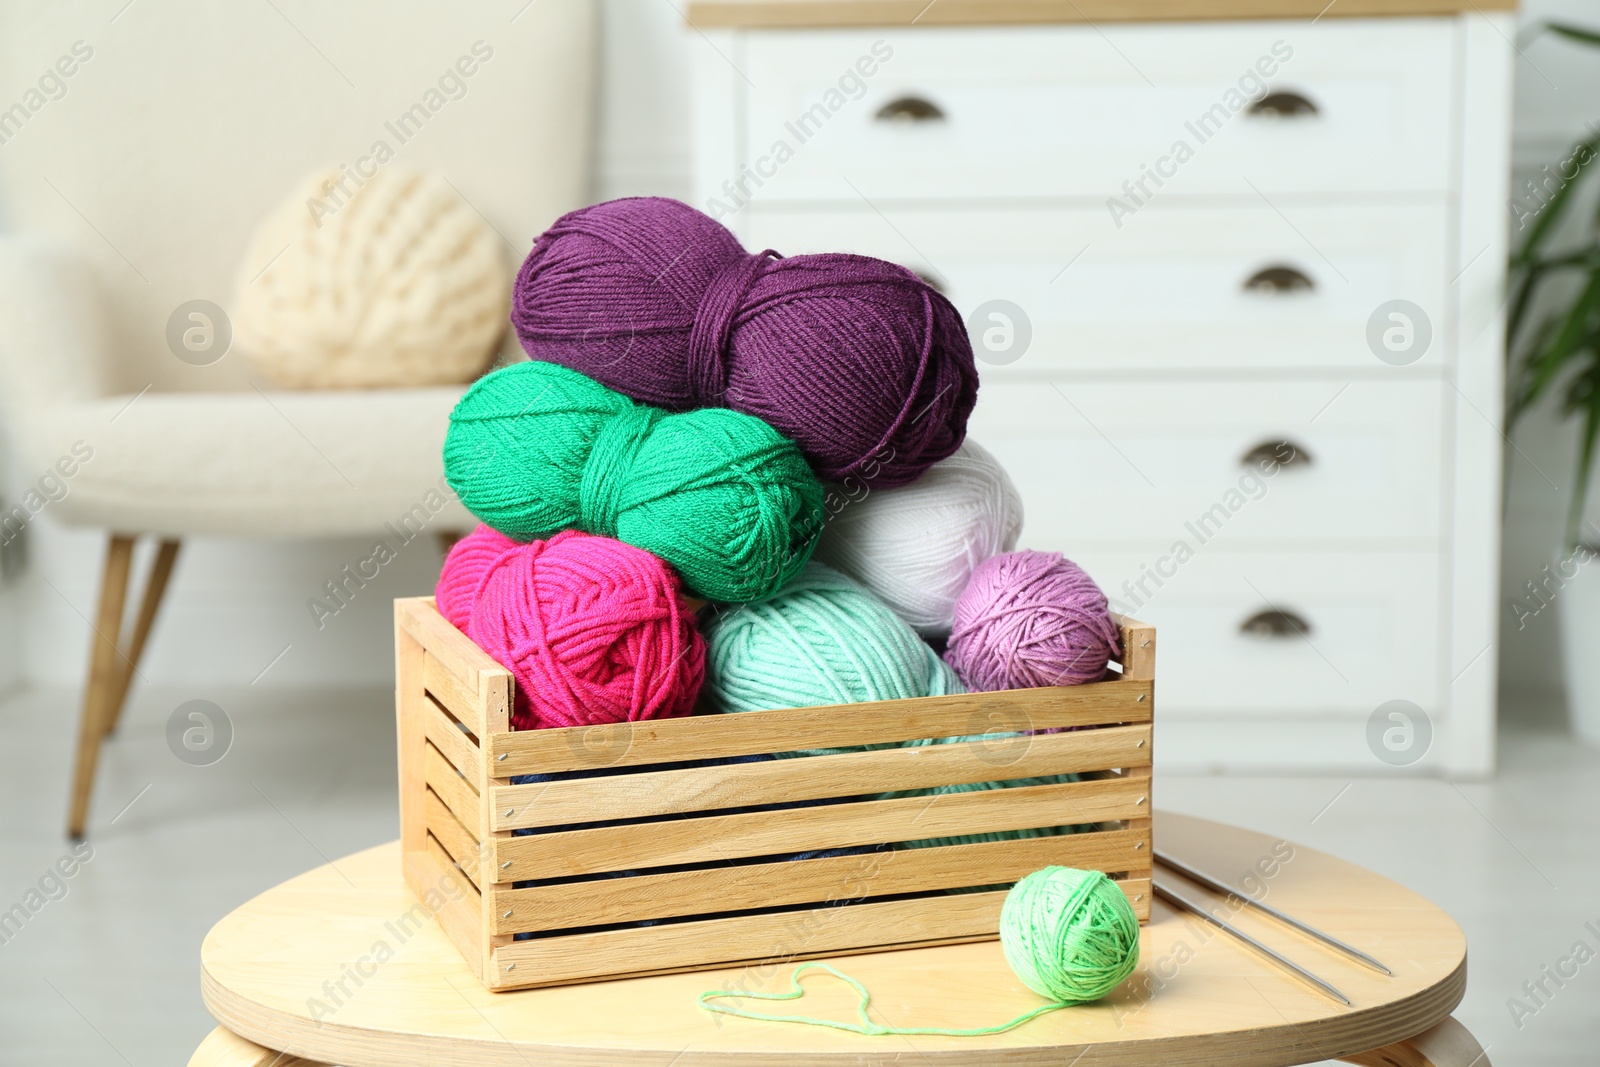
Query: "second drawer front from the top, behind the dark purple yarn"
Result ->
[[741, 202, 1453, 374]]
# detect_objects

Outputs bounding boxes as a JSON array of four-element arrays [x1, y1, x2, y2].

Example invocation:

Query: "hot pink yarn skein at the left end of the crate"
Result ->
[[467, 530, 706, 729]]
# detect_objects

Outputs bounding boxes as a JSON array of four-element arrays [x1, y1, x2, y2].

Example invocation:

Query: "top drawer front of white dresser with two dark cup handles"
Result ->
[[742, 19, 1454, 206]]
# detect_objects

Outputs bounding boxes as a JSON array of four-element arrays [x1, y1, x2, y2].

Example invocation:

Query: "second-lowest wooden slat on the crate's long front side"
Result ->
[[488, 830, 1150, 934]]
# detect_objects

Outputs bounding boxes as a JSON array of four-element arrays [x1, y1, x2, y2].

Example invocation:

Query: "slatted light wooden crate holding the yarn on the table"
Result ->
[[395, 597, 1155, 990]]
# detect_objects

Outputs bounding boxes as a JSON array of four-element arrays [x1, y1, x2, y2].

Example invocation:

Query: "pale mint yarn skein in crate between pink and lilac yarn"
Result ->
[[701, 561, 965, 726]]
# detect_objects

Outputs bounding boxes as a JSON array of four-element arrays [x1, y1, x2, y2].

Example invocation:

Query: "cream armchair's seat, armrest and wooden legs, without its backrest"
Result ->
[[0, 238, 474, 837]]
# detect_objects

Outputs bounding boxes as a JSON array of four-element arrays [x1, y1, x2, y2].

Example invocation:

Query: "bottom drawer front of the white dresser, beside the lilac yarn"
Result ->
[[1074, 549, 1440, 716]]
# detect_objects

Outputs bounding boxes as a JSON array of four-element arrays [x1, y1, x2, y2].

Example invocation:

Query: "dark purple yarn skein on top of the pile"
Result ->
[[510, 197, 978, 486]]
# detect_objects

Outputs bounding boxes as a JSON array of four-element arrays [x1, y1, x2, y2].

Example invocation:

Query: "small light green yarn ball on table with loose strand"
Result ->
[[1000, 867, 1139, 1003]]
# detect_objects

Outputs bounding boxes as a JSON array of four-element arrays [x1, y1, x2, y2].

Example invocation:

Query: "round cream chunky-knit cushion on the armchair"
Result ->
[[232, 170, 510, 389]]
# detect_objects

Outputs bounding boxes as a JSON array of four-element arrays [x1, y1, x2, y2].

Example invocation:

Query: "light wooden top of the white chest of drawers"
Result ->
[[688, 0, 1517, 29]]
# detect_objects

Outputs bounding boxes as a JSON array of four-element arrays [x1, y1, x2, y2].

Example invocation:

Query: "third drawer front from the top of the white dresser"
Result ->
[[970, 381, 1450, 543]]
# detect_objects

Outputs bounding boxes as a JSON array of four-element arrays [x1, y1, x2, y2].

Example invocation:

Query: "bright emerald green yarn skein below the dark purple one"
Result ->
[[445, 362, 822, 601]]
